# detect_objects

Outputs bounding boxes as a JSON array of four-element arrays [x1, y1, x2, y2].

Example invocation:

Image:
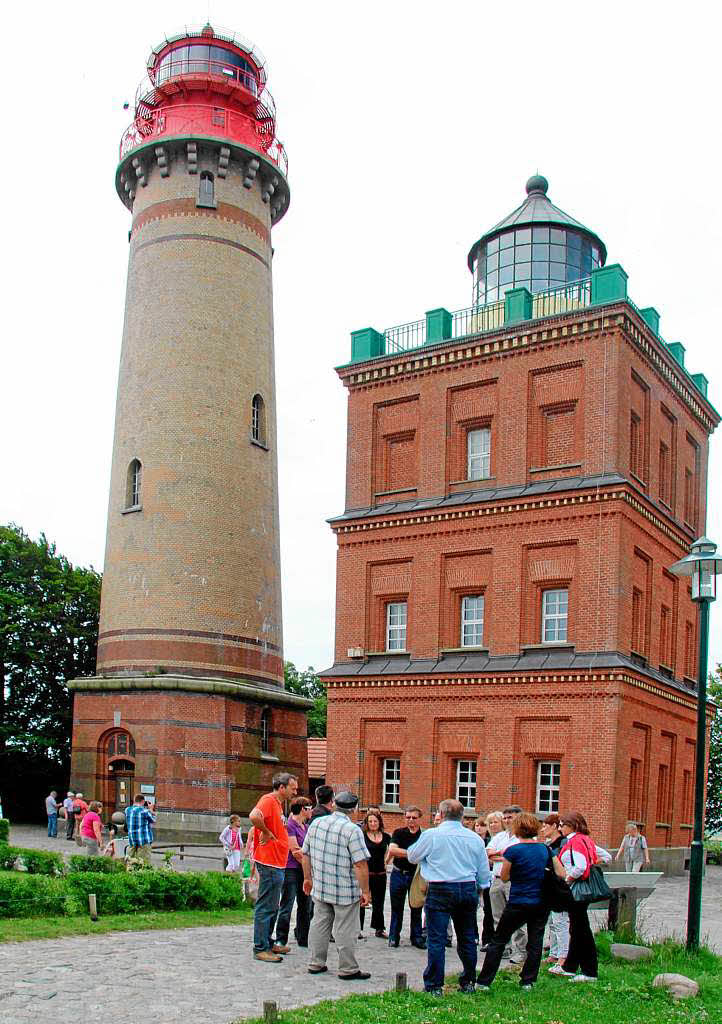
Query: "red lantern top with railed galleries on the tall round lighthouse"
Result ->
[[117, 25, 288, 212]]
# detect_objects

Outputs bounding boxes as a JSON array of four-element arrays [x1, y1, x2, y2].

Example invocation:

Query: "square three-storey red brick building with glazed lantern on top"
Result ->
[[323, 177, 719, 847]]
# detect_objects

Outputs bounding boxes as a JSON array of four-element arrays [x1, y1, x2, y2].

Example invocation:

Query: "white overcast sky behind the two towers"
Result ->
[[0, 0, 722, 669]]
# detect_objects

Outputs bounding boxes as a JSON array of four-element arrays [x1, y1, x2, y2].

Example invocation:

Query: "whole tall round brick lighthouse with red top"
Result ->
[[65, 25, 306, 831]]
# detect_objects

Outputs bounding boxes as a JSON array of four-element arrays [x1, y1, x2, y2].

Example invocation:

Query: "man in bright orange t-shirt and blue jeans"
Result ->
[[249, 771, 298, 964]]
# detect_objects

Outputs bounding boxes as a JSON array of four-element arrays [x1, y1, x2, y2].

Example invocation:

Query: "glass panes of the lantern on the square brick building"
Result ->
[[474, 225, 601, 306]]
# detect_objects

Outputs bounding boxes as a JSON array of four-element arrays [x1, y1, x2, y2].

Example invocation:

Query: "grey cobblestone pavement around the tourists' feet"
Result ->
[[0, 827, 722, 1024]]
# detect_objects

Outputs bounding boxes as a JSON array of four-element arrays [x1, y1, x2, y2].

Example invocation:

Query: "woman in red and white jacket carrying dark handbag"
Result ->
[[549, 811, 611, 982]]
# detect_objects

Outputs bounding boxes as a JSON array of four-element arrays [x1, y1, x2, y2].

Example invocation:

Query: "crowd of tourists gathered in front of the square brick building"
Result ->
[[235, 772, 648, 995]]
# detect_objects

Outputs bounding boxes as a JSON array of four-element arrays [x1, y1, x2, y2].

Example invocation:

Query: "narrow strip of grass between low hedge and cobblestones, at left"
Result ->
[[0, 907, 253, 942]]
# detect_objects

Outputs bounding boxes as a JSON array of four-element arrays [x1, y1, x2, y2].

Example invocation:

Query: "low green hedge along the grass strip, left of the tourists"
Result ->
[[0, 872, 243, 918]]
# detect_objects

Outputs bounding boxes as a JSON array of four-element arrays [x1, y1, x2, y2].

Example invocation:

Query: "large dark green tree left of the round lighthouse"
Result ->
[[0, 525, 100, 811]]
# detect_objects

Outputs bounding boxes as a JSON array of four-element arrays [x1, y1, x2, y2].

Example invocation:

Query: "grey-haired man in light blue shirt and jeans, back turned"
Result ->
[[408, 800, 492, 995]]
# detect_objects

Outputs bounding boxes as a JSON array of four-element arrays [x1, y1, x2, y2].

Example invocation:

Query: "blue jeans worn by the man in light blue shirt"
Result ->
[[424, 882, 479, 992]]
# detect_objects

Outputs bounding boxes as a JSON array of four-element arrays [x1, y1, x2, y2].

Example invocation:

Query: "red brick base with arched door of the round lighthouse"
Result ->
[[68, 675, 310, 839]]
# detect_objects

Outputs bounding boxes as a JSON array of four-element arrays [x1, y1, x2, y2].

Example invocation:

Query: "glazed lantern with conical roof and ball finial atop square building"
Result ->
[[468, 174, 606, 305]]
